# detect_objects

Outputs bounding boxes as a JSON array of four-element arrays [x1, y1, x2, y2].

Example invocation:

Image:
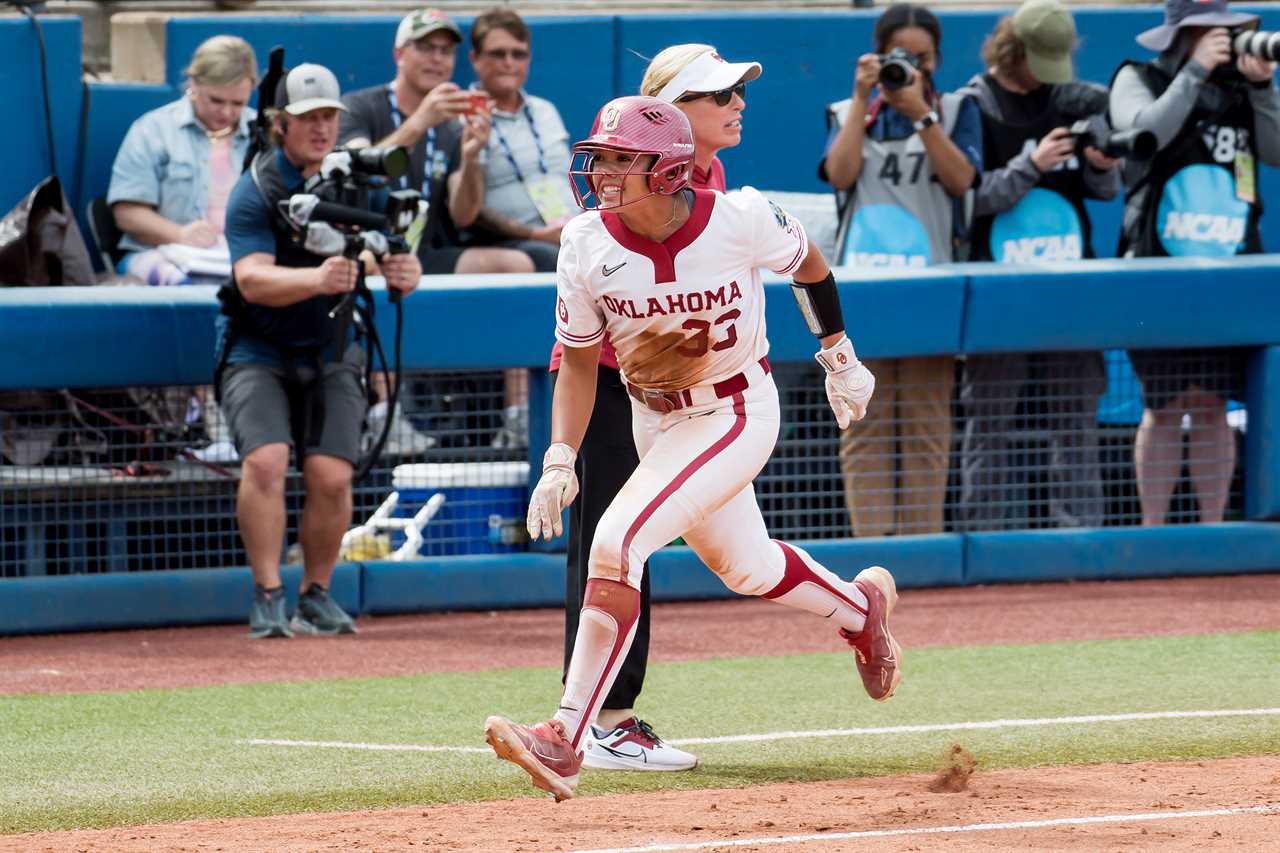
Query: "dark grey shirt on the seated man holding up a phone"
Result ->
[[338, 83, 462, 248]]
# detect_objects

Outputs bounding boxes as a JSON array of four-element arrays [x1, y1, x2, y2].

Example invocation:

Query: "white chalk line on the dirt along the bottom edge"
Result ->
[[572, 803, 1280, 853]]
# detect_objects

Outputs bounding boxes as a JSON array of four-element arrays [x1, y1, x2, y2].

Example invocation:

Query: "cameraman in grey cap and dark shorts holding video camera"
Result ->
[[219, 64, 422, 638]]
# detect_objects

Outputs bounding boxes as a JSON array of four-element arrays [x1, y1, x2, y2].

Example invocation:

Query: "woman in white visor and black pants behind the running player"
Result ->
[[550, 44, 760, 770]]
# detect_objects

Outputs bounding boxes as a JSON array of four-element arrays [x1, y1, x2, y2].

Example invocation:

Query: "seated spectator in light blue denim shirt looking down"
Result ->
[[106, 36, 257, 284]]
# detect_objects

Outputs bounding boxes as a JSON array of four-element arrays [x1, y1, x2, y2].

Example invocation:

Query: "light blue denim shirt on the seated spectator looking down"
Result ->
[[106, 95, 257, 252]]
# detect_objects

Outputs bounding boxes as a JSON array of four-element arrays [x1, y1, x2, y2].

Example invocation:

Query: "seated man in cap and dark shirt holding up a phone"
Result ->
[[339, 9, 524, 456]]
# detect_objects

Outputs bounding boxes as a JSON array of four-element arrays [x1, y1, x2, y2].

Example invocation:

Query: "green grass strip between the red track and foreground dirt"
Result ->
[[0, 631, 1280, 833]]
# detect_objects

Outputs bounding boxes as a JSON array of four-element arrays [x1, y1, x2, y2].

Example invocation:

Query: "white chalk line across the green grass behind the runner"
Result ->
[[236, 708, 1280, 753]]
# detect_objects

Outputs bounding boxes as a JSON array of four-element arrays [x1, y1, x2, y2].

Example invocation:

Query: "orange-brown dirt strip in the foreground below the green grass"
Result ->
[[0, 758, 1280, 853]]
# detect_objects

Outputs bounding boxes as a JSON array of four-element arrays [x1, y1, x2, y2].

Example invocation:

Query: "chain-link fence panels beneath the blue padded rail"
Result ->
[[0, 351, 1244, 578]]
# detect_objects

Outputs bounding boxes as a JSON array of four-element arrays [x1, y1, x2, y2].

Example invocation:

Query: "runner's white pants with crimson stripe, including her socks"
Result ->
[[556, 374, 867, 747]]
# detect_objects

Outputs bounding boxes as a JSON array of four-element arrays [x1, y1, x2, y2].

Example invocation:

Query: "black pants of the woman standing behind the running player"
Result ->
[[564, 365, 649, 710]]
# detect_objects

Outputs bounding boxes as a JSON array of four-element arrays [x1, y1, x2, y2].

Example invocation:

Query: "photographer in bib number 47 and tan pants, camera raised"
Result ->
[[818, 3, 983, 537]]
